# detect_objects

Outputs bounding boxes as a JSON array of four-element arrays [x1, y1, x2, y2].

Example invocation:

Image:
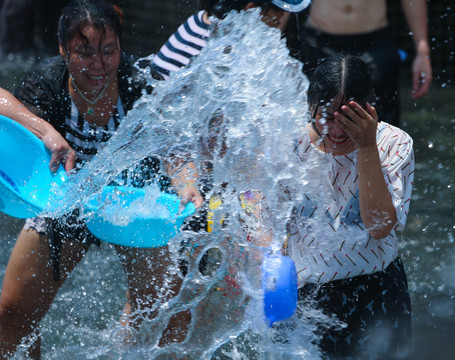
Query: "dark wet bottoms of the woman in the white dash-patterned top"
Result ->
[[299, 258, 411, 359]]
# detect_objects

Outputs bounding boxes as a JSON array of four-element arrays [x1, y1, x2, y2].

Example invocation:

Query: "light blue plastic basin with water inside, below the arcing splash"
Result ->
[[85, 186, 196, 248]]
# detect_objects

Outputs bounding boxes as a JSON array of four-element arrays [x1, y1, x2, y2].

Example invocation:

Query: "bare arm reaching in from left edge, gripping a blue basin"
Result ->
[[0, 88, 76, 172]]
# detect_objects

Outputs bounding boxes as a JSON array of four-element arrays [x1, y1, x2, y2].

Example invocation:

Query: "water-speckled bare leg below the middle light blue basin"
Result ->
[[116, 246, 191, 345]]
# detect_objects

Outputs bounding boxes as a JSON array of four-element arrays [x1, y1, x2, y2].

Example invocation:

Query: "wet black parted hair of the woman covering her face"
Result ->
[[308, 54, 375, 119]]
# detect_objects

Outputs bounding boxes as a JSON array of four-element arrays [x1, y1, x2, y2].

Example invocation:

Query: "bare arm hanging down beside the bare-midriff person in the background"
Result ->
[[401, 0, 433, 98]]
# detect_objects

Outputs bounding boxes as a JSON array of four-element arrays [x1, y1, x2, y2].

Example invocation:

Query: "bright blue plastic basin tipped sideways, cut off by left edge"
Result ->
[[0, 115, 66, 219]]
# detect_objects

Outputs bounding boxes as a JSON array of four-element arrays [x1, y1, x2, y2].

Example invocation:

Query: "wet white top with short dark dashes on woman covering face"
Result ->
[[287, 122, 414, 284]]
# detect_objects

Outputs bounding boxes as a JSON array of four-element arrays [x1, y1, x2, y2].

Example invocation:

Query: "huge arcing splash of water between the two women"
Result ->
[[44, 11, 326, 359]]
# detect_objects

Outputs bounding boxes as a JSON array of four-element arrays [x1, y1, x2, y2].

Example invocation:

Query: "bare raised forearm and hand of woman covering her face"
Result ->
[[335, 101, 397, 239]]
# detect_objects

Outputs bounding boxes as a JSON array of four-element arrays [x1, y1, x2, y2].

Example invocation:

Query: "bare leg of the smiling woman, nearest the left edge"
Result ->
[[0, 229, 88, 359]]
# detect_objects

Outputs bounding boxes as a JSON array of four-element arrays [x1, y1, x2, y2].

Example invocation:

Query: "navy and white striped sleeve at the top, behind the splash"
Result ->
[[153, 10, 211, 79]]
